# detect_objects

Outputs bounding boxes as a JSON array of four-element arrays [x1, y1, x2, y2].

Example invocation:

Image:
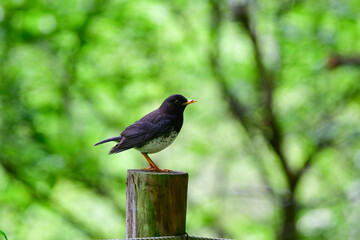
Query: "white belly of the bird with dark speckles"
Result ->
[[136, 130, 178, 153]]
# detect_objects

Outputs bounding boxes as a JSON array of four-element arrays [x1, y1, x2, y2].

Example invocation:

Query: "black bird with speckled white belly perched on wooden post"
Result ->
[[94, 94, 196, 172]]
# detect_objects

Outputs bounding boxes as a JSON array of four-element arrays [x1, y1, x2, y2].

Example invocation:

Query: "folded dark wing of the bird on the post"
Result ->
[[109, 116, 174, 154]]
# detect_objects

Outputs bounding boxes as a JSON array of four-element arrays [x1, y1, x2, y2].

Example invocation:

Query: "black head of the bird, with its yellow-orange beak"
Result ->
[[160, 94, 196, 115]]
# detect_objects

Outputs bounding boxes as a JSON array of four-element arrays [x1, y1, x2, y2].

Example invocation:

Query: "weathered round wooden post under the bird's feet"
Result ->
[[126, 169, 188, 238]]
